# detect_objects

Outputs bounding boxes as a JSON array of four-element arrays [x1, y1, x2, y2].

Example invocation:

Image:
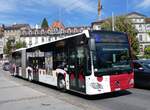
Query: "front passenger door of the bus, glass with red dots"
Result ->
[[69, 47, 86, 92]]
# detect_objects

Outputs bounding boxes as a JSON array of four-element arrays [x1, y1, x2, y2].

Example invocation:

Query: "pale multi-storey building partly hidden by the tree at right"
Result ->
[[92, 12, 150, 55]]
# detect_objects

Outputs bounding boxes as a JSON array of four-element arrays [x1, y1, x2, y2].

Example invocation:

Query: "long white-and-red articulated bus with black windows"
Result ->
[[12, 30, 134, 95]]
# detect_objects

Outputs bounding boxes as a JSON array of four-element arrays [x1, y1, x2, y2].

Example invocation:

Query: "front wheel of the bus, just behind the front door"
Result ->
[[57, 75, 66, 92]]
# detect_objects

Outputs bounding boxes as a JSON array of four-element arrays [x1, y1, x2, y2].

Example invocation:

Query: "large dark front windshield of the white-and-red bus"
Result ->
[[94, 43, 131, 75]]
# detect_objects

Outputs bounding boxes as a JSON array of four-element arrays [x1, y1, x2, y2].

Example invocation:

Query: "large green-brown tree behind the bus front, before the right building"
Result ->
[[101, 16, 139, 55]]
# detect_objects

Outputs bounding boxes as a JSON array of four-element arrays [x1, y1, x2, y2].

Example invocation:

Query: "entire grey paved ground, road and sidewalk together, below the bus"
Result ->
[[0, 70, 150, 110]]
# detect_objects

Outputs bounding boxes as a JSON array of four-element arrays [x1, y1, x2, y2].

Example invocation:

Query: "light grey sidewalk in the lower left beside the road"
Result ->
[[0, 70, 82, 110]]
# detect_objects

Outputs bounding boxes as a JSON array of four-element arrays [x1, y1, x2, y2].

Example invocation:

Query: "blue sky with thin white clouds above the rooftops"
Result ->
[[0, 0, 150, 26]]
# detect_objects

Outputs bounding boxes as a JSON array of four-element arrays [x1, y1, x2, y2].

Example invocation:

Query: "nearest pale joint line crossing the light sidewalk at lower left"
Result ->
[[0, 95, 47, 105]]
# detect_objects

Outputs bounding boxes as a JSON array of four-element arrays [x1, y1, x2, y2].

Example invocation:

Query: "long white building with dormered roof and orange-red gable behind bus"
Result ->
[[20, 21, 91, 47]]
